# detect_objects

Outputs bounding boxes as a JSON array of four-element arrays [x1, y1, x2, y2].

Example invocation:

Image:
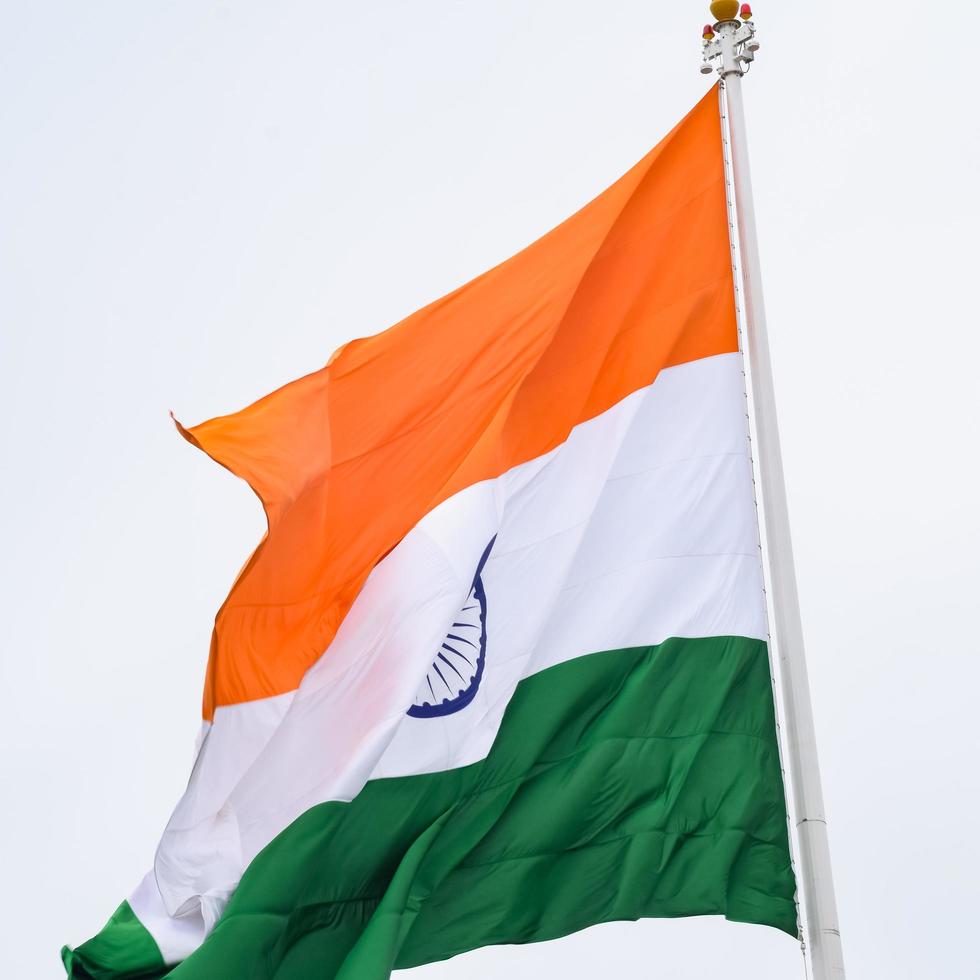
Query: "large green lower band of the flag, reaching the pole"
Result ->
[[63, 637, 797, 980]]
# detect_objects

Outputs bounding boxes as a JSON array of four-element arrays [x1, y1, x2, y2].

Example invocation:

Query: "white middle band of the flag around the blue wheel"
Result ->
[[132, 354, 766, 948]]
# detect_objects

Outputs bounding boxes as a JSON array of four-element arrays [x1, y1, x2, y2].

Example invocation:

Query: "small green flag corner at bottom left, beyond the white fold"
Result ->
[[61, 902, 167, 980]]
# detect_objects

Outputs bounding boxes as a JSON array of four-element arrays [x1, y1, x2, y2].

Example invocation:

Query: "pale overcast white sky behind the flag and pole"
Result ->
[[0, 0, 980, 980]]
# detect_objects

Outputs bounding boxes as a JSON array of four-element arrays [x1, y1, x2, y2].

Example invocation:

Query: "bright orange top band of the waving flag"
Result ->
[[181, 89, 738, 718]]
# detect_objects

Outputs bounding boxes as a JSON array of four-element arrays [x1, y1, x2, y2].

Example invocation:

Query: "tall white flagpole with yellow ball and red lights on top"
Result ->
[[701, 0, 844, 980]]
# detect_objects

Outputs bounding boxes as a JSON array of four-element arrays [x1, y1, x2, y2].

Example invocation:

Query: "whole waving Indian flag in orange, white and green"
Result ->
[[63, 90, 797, 980]]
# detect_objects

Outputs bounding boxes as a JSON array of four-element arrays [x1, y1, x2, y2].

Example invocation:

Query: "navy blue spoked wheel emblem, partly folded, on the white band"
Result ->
[[408, 537, 497, 718]]
